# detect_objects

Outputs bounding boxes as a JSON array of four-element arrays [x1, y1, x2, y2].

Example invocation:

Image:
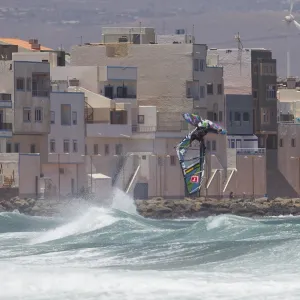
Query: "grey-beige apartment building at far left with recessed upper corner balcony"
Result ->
[[0, 61, 50, 161]]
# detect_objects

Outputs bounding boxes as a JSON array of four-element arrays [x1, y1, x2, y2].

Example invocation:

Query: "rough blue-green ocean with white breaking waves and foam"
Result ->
[[0, 191, 300, 300]]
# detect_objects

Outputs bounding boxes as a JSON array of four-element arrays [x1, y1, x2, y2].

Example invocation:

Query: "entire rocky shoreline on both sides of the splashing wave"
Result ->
[[0, 197, 300, 219]]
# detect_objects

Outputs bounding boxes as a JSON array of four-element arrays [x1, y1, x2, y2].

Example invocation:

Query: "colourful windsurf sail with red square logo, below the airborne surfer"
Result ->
[[176, 132, 205, 194]]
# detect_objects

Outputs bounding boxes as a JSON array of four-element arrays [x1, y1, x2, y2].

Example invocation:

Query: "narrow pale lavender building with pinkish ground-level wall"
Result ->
[[42, 88, 86, 195]]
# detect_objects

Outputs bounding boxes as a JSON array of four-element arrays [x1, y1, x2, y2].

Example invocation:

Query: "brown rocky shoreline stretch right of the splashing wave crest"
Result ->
[[136, 198, 300, 219]]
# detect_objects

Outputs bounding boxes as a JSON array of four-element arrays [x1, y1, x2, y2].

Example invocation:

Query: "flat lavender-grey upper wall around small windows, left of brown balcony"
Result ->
[[48, 92, 85, 163]]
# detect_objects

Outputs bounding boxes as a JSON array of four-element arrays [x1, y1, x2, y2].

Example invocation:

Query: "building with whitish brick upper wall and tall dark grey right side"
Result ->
[[208, 49, 277, 149]]
